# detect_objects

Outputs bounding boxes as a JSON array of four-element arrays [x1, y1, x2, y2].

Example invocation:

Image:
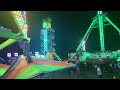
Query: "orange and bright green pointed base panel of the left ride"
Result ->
[[0, 55, 74, 79]]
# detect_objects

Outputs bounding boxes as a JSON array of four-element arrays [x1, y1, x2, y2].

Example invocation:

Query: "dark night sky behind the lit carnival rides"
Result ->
[[0, 11, 120, 57]]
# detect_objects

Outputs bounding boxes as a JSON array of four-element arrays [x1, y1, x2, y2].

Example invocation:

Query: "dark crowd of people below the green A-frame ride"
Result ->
[[68, 56, 120, 79]]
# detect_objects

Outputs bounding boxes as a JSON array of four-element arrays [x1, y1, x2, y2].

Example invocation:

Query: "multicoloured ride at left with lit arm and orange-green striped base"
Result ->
[[0, 11, 75, 79]]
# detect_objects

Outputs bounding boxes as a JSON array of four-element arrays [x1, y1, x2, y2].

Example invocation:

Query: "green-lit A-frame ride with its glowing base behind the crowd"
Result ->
[[69, 11, 120, 61]]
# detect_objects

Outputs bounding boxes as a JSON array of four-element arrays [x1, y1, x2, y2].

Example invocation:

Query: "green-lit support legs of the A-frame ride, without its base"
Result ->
[[69, 11, 120, 60]]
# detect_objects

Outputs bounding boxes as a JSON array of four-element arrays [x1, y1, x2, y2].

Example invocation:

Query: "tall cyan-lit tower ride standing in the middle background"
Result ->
[[40, 17, 61, 61]]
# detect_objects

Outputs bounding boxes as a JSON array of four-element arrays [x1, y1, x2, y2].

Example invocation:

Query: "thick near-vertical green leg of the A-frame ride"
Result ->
[[97, 11, 105, 52]]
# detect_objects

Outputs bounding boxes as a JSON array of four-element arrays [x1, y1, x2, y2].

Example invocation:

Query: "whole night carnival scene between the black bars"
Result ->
[[0, 11, 120, 79]]
